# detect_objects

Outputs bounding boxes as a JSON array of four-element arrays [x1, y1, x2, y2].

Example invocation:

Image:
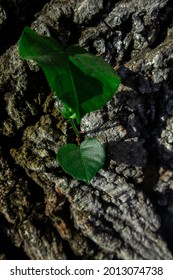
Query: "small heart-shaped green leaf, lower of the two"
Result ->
[[57, 138, 105, 184]]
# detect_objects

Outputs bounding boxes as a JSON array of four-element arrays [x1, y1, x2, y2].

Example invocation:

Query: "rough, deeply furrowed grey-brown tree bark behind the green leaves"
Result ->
[[0, 0, 173, 260]]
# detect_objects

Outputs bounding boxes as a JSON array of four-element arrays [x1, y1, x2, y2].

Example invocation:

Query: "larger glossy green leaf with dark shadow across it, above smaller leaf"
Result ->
[[19, 27, 120, 124]]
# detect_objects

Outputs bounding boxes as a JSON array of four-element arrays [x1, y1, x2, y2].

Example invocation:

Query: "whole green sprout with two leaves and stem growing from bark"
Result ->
[[19, 27, 120, 184]]
